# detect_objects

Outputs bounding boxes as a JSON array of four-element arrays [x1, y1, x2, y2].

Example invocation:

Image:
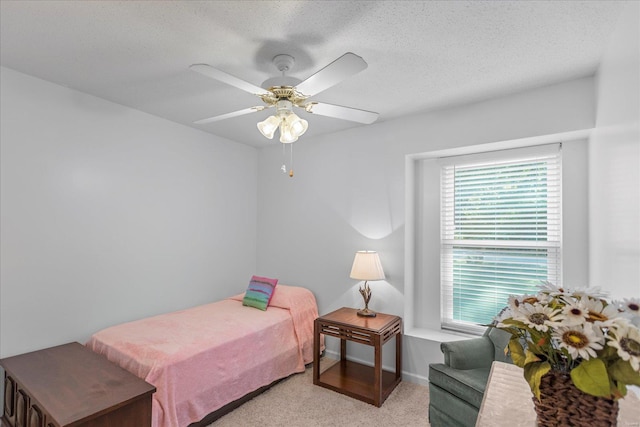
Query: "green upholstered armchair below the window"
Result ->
[[429, 328, 511, 427]]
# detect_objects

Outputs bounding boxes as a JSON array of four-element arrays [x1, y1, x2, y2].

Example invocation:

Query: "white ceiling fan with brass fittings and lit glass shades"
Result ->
[[189, 52, 378, 144]]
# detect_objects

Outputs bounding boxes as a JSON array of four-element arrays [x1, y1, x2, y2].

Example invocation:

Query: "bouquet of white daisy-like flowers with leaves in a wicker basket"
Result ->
[[495, 282, 640, 425]]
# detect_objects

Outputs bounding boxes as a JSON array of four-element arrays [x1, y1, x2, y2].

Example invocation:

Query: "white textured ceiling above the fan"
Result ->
[[0, 0, 624, 147]]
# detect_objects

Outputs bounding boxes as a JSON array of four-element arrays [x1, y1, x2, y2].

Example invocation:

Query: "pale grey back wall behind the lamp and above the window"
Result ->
[[258, 78, 595, 380]]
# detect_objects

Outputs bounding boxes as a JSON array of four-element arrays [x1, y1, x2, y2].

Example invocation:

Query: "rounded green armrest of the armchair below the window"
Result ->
[[440, 336, 494, 369]]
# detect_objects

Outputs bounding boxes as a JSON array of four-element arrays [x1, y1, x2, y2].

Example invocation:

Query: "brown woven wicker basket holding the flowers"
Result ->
[[533, 370, 618, 427]]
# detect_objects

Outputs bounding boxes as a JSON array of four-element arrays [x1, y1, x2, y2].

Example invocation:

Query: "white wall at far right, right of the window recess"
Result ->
[[589, 2, 640, 298]]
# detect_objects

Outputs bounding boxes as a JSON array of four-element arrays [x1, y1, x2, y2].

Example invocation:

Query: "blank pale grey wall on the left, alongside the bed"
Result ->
[[0, 68, 257, 357]]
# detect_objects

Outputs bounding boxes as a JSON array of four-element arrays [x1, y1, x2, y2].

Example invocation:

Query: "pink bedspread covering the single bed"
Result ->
[[86, 285, 318, 427]]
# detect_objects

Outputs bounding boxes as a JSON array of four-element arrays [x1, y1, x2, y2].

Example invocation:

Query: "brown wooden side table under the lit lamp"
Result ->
[[313, 307, 402, 407]]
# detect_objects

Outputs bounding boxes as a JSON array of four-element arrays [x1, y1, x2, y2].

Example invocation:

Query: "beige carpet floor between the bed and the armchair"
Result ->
[[210, 359, 429, 427]]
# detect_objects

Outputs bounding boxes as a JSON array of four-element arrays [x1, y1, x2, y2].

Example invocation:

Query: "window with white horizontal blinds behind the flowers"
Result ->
[[440, 144, 562, 332]]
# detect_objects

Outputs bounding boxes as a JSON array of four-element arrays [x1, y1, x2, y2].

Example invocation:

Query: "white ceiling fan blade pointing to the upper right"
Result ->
[[296, 52, 367, 96]]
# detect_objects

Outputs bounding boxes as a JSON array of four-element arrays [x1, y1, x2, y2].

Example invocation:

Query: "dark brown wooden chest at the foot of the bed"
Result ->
[[0, 343, 155, 427]]
